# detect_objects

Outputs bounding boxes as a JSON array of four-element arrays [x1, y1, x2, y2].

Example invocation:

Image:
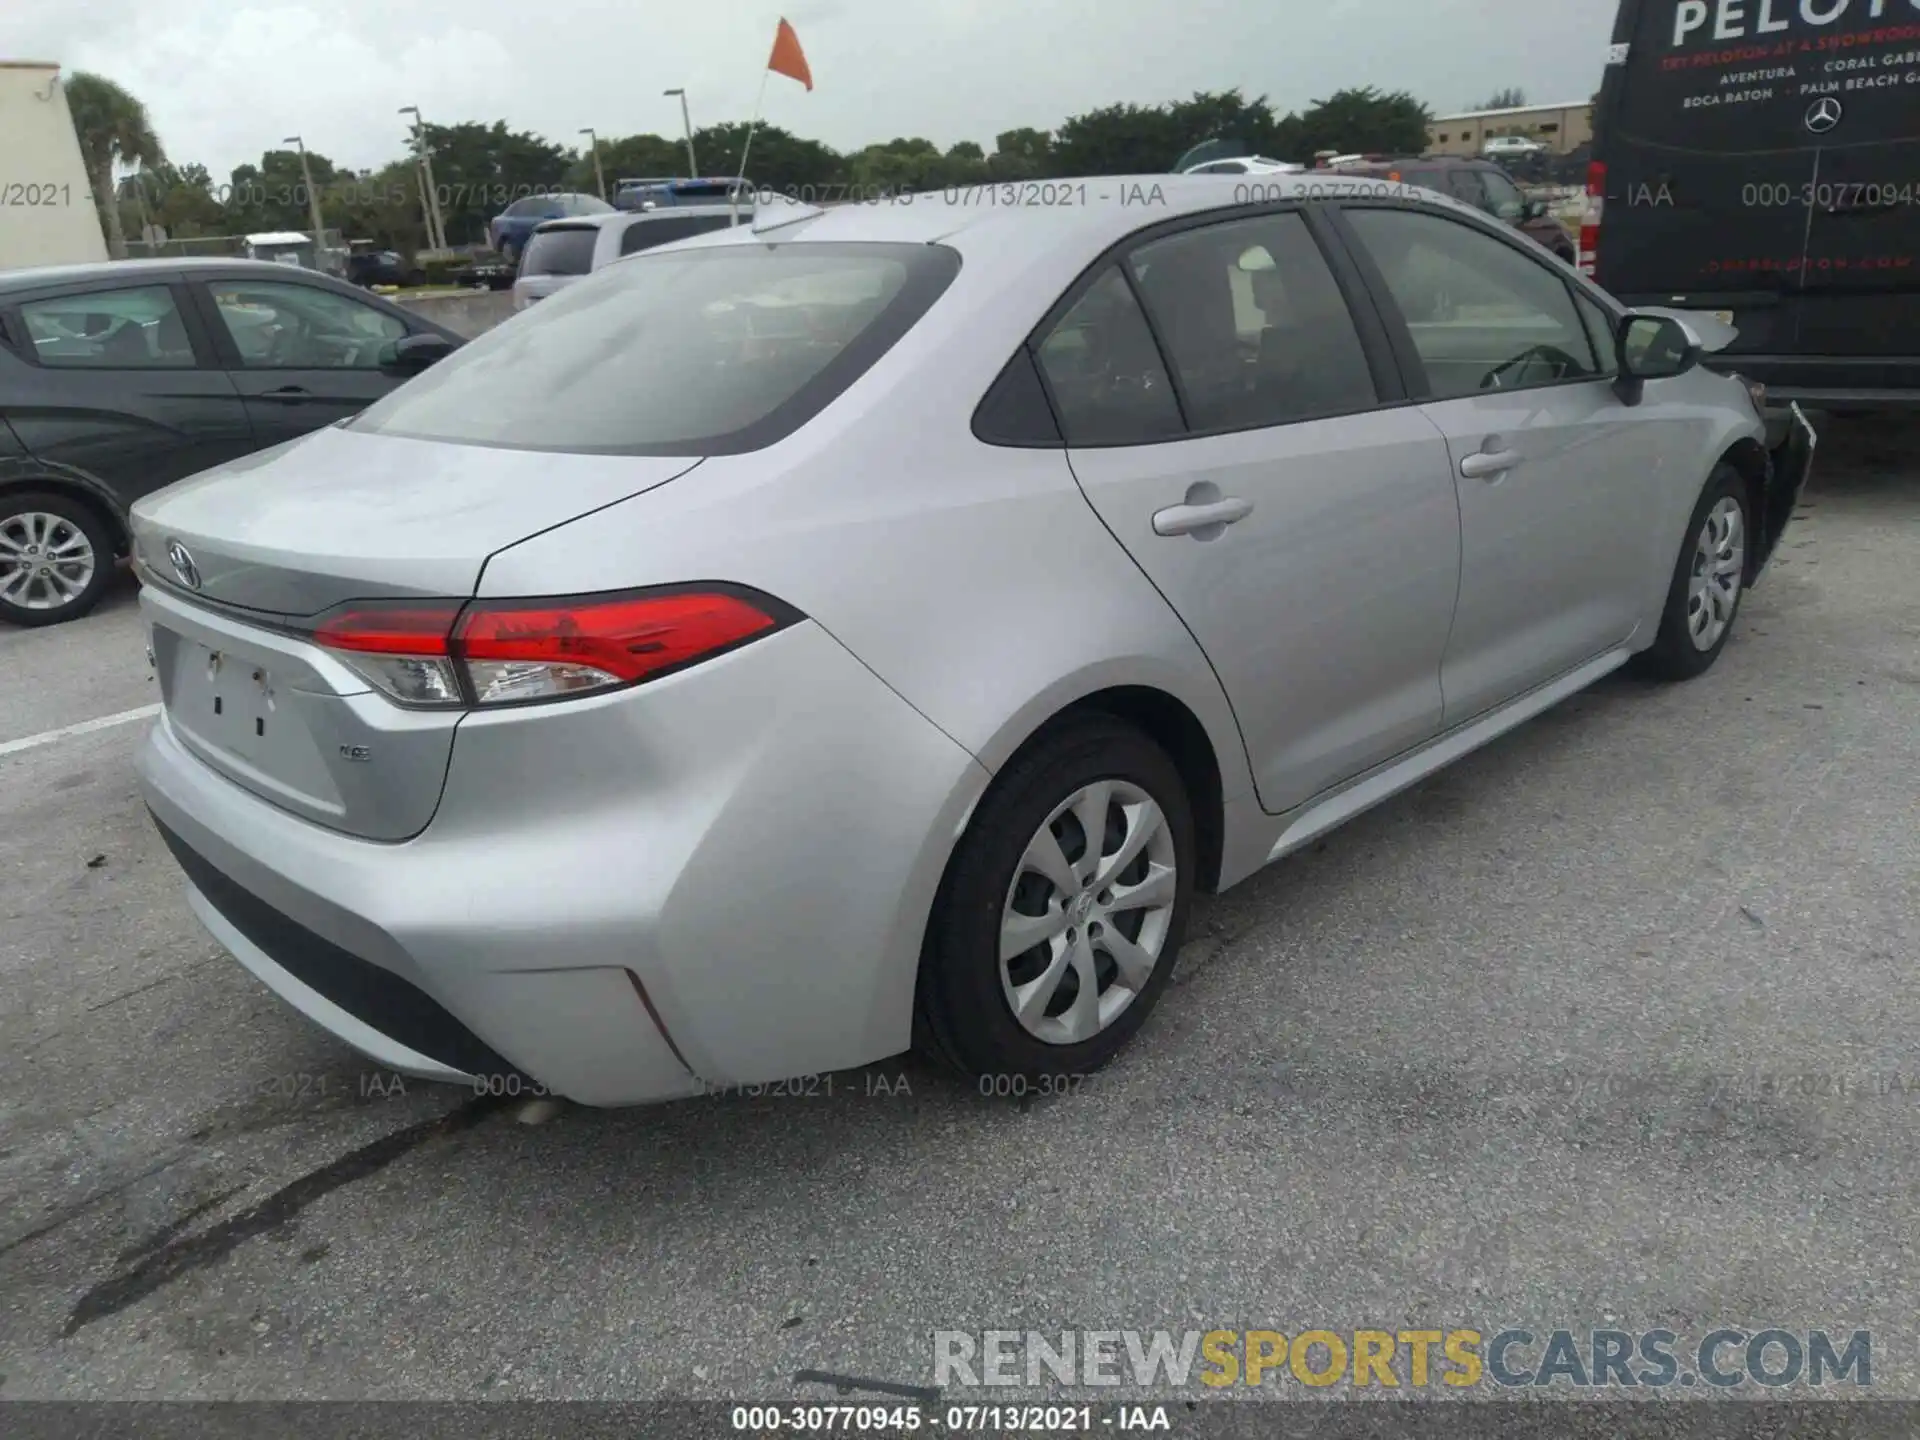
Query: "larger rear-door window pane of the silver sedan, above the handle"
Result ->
[[1131, 213, 1379, 430]]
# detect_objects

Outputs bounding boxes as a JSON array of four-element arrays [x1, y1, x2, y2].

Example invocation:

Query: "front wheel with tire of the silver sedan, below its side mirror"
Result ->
[[1634, 461, 1753, 680]]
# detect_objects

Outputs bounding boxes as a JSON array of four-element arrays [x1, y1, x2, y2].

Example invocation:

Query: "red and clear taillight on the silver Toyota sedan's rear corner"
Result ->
[[313, 586, 795, 707]]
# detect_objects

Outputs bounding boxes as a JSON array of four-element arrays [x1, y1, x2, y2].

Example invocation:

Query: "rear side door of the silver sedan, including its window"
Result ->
[[1039, 211, 1459, 812]]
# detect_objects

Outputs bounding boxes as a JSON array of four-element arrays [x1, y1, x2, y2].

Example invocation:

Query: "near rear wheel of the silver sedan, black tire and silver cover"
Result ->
[[914, 716, 1196, 1092]]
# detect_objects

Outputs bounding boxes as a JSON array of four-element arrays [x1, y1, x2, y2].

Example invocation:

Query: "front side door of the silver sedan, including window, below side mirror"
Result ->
[[1342, 205, 1670, 726]]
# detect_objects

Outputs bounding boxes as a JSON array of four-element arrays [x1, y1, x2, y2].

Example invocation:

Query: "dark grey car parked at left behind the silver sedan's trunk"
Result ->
[[0, 259, 461, 626]]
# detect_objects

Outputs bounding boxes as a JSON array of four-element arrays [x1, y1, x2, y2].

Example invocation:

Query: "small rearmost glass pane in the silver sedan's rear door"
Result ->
[[1039, 265, 1187, 445]]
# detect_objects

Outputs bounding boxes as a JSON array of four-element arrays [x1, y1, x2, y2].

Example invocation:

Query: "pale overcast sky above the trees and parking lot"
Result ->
[[0, 0, 1615, 180]]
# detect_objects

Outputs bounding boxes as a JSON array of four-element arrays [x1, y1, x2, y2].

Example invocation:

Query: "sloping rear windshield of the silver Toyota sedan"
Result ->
[[349, 242, 960, 455]]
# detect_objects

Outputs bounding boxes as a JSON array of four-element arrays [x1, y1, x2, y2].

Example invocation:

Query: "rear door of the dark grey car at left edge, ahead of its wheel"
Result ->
[[0, 278, 257, 505]]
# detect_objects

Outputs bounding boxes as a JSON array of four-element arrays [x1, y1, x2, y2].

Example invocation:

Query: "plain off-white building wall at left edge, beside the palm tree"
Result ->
[[0, 60, 108, 271]]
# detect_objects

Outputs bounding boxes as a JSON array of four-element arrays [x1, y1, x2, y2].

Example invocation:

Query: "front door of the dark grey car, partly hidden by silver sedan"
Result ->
[[192, 276, 409, 445]]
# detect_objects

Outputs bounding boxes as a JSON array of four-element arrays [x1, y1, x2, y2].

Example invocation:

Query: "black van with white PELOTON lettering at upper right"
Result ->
[[1596, 0, 1920, 388]]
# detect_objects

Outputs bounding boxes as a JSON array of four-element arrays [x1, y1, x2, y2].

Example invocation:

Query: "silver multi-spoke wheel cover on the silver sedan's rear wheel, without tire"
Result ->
[[1000, 780, 1179, 1044]]
